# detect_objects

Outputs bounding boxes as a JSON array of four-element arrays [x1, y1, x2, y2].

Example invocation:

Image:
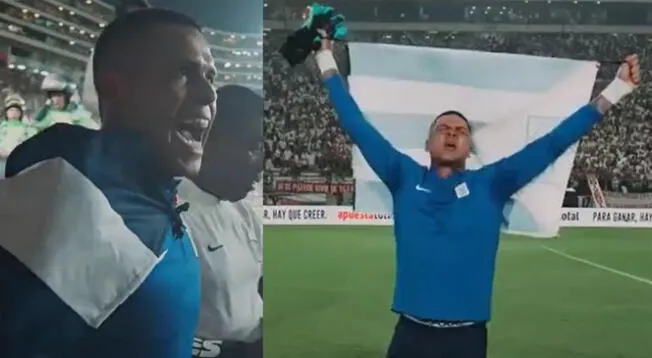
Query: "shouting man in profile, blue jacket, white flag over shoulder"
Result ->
[[0, 9, 217, 358]]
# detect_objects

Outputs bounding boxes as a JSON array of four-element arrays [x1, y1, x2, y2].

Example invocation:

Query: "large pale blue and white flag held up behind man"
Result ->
[[349, 43, 598, 237]]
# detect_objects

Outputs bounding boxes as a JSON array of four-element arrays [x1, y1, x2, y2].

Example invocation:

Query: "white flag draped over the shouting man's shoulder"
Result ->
[[0, 158, 164, 328]]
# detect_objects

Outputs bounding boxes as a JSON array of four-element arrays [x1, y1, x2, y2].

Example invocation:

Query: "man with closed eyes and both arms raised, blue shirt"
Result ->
[[300, 6, 641, 358]]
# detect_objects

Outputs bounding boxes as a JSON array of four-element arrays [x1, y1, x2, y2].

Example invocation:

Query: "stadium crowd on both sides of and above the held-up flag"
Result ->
[[264, 31, 652, 204]]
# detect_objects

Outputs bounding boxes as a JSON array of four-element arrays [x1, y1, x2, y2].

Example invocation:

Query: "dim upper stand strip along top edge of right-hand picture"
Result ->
[[264, 0, 652, 26]]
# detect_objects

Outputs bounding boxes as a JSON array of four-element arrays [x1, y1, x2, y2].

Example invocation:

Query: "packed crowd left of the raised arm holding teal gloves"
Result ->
[[263, 33, 352, 177]]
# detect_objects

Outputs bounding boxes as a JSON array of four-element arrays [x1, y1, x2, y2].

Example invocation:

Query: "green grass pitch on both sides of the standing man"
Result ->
[[264, 226, 652, 358]]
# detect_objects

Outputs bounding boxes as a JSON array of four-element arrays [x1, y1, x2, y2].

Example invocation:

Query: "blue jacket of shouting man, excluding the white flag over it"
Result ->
[[0, 124, 200, 358]]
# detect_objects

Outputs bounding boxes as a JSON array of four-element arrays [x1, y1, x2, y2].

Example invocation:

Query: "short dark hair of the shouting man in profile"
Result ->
[[93, 8, 201, 94]]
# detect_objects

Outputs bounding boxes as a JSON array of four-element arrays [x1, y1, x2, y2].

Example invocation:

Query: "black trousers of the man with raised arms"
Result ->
[[387, 316, 487, 358]]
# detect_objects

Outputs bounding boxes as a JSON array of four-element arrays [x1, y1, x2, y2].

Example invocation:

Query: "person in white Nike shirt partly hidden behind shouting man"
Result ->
[[83, 0, 262, 358]]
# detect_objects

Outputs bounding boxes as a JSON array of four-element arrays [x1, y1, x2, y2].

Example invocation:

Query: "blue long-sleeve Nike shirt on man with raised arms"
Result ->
[[324, 75, 601, 322]]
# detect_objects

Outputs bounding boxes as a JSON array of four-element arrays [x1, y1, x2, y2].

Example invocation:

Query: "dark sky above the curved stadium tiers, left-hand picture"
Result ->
[[105, 0, 263, 34]]
